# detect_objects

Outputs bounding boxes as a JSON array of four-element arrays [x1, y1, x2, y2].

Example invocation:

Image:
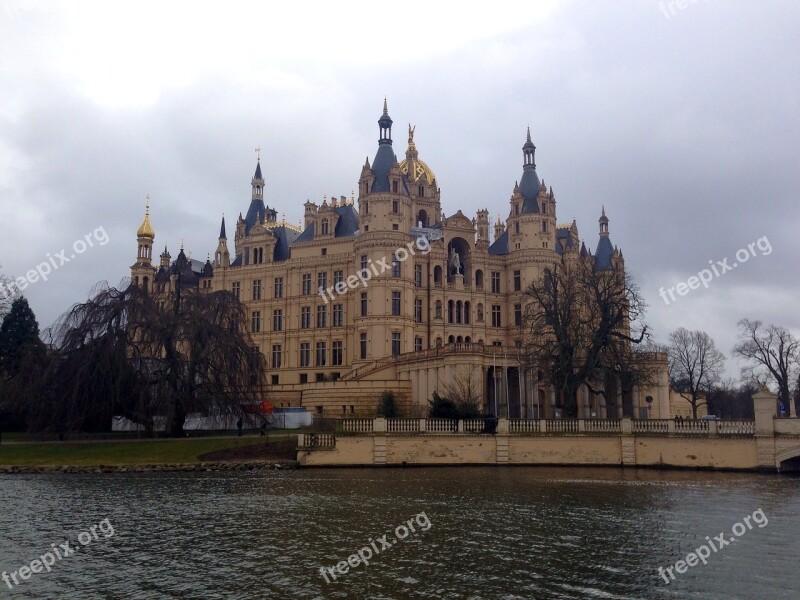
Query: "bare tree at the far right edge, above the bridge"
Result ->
[[733, 319, 800, 408]]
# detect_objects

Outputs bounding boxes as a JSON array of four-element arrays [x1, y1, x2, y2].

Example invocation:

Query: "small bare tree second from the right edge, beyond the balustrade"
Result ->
[[668, 327, 725, 419]]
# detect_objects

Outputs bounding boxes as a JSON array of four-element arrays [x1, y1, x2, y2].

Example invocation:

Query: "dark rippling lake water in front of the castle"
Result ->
[[0, 467, 800, 600]]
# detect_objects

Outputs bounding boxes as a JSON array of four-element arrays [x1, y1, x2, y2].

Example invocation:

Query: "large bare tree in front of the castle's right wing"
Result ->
[[520, 253, 658, 417]]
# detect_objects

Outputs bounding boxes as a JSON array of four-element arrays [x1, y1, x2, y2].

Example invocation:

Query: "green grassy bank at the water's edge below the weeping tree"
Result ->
[[0, 432, 296, 466]]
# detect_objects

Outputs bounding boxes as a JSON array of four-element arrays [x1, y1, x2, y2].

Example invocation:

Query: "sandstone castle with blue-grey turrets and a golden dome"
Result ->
[[131, 101, 670, 418]]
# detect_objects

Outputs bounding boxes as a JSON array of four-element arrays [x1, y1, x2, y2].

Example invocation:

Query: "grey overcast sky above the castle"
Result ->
[[0, 0, 800, 374]]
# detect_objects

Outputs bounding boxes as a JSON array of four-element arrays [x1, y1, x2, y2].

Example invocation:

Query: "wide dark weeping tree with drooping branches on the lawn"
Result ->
[[20, 284, 264, 435]]
